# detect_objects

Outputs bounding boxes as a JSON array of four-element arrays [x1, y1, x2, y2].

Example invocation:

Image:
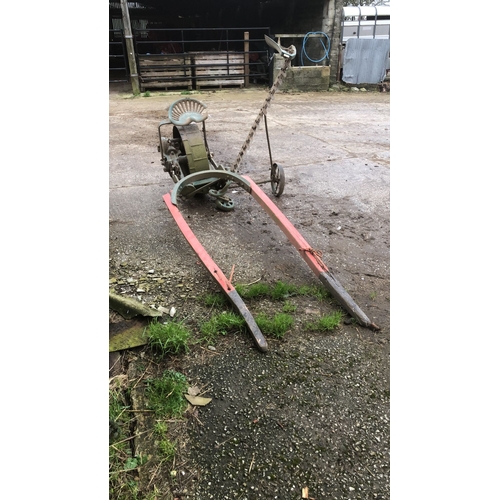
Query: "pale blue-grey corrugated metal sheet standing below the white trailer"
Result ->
[[342, 38, 390, 84]]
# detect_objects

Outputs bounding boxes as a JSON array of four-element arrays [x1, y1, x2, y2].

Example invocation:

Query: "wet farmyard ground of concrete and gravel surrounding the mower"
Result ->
[[109, 89, 390, 500]]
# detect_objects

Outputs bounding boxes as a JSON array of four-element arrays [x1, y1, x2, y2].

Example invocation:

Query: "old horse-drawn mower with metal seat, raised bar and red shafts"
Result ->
[[158, 37, 379, 352]]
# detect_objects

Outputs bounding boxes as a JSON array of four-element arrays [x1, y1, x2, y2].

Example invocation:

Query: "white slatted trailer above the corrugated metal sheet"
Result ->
[[341, 5, 391, 45]]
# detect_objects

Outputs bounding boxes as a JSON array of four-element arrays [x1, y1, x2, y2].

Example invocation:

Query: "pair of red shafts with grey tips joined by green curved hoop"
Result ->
[[163, 170, 380, 352]]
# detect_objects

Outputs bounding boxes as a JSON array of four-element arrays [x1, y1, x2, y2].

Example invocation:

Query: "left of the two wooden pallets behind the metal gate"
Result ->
[[139, 54, 193, 90]]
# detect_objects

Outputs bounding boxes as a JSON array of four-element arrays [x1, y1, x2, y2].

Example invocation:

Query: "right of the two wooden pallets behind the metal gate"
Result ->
[[191, 52, 245, 89]]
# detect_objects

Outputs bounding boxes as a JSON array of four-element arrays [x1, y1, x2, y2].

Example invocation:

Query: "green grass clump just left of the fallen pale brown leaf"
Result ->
[[146, 370, 188, 418]]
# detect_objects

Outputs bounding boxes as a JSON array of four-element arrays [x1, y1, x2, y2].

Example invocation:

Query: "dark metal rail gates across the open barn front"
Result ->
[[110, 27, 272, 90]]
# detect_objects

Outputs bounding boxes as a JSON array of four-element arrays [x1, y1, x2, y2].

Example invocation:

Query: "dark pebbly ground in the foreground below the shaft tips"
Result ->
[[185, 330, 389, 500]]
